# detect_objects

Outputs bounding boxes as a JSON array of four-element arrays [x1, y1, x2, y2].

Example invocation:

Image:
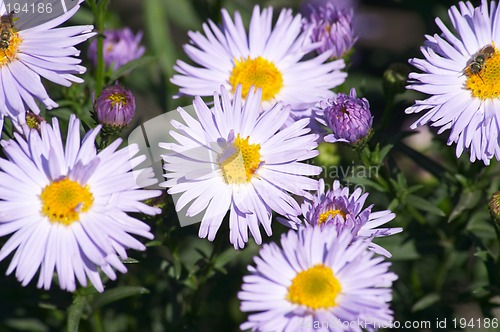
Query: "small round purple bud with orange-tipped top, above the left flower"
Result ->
[[94, 84, 135, 128]]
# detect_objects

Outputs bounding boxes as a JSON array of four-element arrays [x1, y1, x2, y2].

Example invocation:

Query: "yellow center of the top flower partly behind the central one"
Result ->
[[229, 56, 283, 101]]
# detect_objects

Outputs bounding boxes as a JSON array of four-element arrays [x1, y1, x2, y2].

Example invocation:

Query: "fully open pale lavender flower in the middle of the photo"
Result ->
[[160, 86, 321, 248]]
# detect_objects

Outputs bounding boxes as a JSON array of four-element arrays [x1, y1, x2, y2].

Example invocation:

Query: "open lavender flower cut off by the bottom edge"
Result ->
[[238, 227, 397, 332]]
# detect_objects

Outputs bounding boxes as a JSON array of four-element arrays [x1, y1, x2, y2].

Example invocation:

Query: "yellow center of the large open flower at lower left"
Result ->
[[40, 178, 94, 226]]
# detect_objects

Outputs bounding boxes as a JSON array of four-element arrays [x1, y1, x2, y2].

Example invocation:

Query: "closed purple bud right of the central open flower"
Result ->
[[315, 88, 373, 144]]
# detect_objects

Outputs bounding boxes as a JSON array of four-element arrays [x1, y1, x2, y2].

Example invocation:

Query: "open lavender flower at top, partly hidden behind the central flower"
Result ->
[[171, 6, 347, 115]]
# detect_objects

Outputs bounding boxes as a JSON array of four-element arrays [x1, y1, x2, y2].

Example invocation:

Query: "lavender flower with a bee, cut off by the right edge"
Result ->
[[406, 0, 500, 165]]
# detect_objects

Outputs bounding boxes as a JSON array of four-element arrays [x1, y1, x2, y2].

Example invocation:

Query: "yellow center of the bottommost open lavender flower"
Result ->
[[287, 264, 342, 309]]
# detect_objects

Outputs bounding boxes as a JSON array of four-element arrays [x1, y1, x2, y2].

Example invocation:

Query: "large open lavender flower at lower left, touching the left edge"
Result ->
[[0, 115, 161, 292]]
